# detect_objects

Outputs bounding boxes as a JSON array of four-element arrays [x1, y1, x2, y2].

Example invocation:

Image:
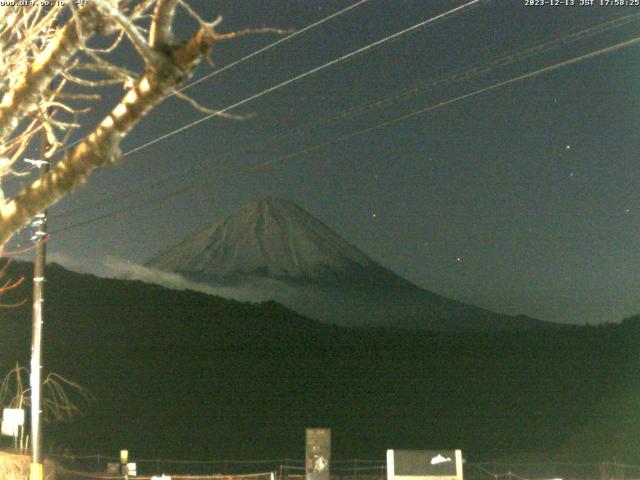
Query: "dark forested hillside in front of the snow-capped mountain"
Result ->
[[0, 264, 640, 461]]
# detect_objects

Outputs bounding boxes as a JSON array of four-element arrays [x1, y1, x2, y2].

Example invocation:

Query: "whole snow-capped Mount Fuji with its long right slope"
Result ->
[[147, 197, 560, 331]]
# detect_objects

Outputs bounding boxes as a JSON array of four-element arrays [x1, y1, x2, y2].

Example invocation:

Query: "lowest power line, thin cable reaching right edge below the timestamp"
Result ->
[[51, 37, 640, 235]]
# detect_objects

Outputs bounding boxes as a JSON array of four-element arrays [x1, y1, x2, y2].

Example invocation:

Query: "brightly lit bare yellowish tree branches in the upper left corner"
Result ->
[[0, 0, 273, 245]]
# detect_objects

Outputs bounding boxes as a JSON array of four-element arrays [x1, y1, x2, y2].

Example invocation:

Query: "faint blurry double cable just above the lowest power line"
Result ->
[[51, 9, 640, 218]]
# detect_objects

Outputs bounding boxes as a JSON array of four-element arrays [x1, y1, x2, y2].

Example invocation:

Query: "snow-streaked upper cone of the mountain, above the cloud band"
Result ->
[[149, 197, 376, 281]]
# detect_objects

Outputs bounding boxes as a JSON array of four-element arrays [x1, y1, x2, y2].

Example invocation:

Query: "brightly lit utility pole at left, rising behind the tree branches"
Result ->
[[30, 132, 49, 480]]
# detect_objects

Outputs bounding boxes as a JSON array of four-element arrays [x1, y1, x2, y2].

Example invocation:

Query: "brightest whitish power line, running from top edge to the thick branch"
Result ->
[[123, 0, 491, 157]]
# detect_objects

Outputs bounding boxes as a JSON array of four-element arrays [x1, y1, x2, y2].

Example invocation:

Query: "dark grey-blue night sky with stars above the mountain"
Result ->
[[6, 0, 640, 324]]
